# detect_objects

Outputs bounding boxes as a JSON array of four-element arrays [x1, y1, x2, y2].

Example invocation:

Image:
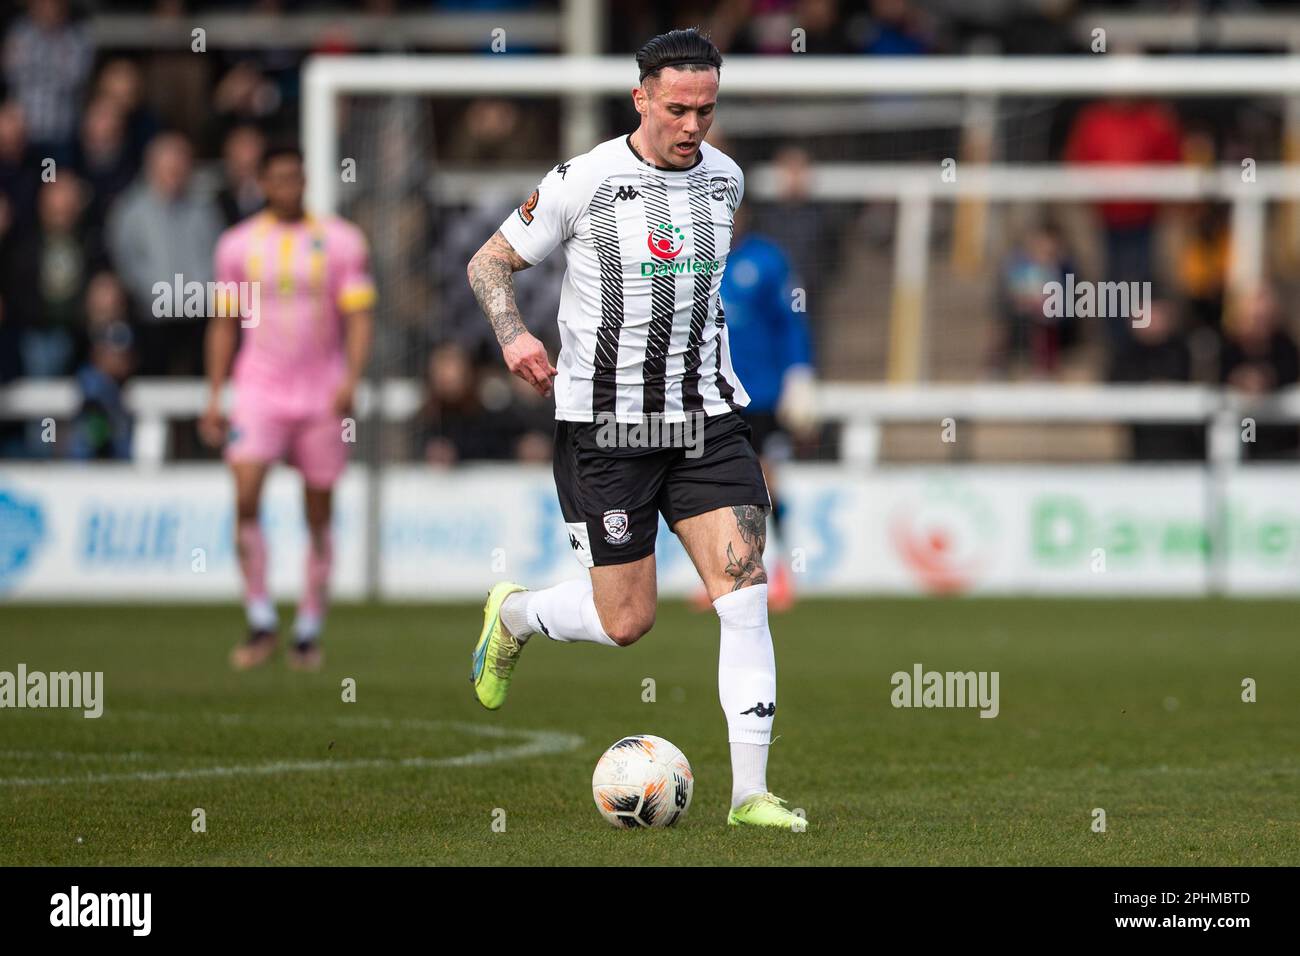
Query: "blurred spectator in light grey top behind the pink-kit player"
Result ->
[[108, 133, 221, 375]]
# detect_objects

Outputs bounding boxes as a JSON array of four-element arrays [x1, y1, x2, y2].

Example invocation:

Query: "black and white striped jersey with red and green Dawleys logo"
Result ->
[[501, 137, 749, 423]]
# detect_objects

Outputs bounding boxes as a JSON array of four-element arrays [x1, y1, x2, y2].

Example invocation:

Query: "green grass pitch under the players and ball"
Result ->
[[0, 600, 1300, 866]]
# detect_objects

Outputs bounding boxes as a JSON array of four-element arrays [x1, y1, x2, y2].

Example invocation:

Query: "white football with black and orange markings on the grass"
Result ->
[[592, 734, 696, 829]]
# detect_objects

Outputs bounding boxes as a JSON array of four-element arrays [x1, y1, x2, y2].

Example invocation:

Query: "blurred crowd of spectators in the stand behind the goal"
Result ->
[[0, 0, 1300, 466]]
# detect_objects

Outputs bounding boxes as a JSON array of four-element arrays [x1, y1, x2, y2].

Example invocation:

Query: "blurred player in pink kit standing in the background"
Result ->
[[199, 150, 374, 670]]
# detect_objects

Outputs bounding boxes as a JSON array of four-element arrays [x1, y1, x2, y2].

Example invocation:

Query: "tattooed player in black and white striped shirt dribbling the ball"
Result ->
[[468, 30, 803, 829]]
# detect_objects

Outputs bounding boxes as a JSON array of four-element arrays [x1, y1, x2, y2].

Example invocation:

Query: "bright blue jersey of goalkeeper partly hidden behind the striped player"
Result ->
[[722, 233, 813, 412]]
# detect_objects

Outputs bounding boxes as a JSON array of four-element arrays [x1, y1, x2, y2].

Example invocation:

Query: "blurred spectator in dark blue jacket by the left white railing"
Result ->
[[70, 319, 135, 460]]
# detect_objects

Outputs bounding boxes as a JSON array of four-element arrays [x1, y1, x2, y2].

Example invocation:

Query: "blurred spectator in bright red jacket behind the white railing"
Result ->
[[1065, 96, 1182, 347]]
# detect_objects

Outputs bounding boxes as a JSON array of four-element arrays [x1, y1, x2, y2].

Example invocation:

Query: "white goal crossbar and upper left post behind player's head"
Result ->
[[302, 55, 1300, 212]]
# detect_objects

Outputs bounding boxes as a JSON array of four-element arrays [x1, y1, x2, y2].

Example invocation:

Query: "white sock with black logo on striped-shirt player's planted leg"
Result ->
[[714, 584, 776, 806]]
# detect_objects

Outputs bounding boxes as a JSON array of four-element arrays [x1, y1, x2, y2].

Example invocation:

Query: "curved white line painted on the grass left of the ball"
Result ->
[[0, 711, 582, 787]]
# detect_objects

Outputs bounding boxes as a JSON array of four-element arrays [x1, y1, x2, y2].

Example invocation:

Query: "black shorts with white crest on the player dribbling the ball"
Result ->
[[554, 412, 771, 567]]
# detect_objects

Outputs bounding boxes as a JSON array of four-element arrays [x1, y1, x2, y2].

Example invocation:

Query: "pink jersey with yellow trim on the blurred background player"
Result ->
[[216, 212, 374, 412]]
